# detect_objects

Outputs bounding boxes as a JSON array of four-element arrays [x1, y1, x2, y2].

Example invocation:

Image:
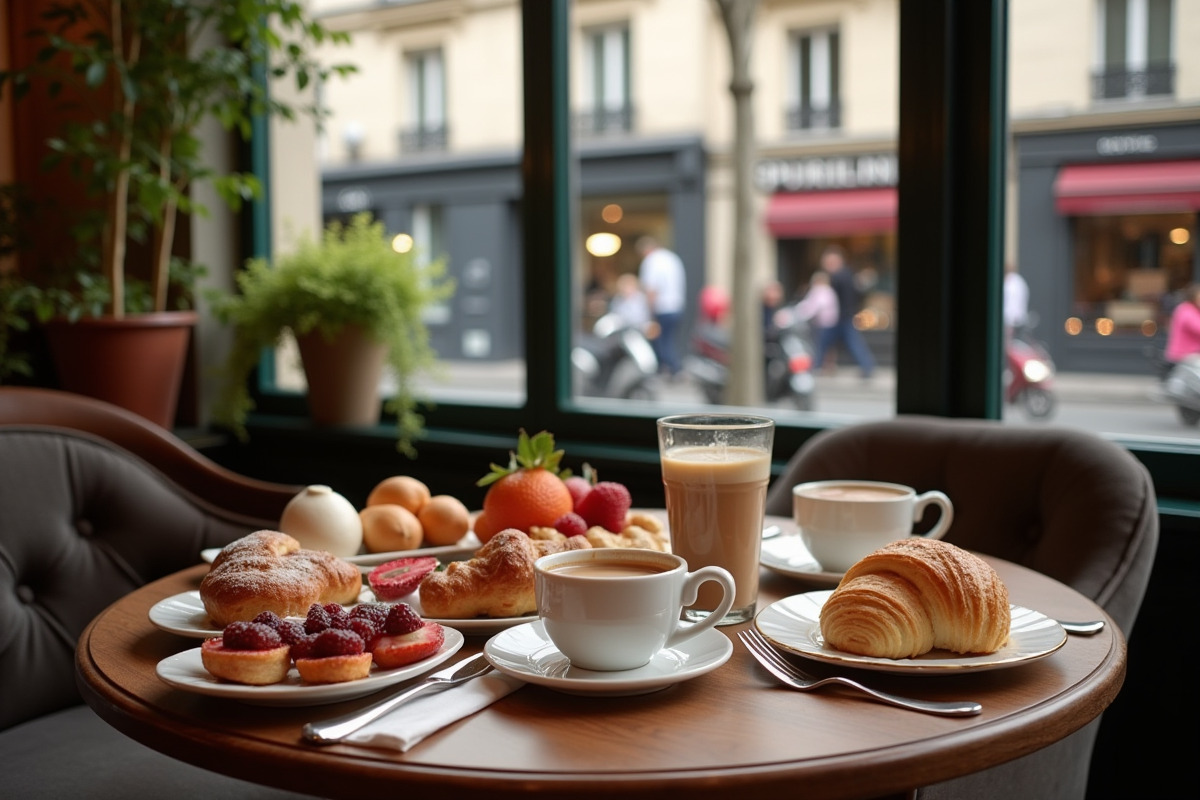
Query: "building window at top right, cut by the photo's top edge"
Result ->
[[1092, 0, 1175, 100]]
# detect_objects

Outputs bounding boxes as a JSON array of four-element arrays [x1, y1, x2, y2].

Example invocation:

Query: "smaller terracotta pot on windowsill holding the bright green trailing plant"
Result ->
[[296, 325, 388, 426]]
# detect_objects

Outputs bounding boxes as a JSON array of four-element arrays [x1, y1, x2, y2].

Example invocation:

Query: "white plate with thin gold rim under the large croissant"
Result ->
[[755, 590, 1067, 675]]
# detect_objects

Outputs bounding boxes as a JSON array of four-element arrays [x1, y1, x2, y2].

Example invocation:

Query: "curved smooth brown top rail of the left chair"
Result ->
[[0, 386, 304, 518]]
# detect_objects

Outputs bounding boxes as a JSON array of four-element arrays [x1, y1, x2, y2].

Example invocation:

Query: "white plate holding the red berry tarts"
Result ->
[[156, 627, 463, 705]]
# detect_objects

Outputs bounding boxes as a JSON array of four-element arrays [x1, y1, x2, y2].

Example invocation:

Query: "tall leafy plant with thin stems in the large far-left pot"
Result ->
[[0, 0, 353, 425]]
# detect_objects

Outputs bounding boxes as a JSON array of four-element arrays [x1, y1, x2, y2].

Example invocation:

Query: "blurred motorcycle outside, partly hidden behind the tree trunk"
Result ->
[[683, 321, 816, 411]]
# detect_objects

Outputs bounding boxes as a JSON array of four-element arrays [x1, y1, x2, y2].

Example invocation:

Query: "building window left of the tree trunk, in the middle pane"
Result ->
[[575, 25, 634, 134]]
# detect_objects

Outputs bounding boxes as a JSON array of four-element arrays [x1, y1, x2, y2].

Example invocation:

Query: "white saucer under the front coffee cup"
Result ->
[[484, 620, 733, 696]]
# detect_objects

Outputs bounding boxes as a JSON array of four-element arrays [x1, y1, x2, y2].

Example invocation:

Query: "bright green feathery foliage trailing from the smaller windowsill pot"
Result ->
[[208, 213, 455, 456]]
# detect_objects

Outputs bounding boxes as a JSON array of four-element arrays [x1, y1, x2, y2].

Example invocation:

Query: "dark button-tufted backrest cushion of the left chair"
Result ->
[[0, 425, 294, 729]]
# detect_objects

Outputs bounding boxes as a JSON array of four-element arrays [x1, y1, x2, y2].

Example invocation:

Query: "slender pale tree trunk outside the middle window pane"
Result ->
[[716, 0, 764, 405]]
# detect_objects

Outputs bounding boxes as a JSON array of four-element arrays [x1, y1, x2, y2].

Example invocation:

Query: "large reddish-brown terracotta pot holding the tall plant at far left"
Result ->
[[46, 311, 199, 428]]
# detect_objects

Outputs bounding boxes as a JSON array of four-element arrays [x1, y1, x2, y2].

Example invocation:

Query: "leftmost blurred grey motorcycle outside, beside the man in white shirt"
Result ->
[[571, 312, 659, 401]]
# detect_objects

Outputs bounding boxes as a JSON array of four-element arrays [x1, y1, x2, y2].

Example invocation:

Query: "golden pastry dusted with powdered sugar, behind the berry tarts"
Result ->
[[200, 530, 362, 627]]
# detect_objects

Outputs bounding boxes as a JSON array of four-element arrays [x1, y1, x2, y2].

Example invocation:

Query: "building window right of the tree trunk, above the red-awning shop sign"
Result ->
[[787, 28, 841, 131]]
